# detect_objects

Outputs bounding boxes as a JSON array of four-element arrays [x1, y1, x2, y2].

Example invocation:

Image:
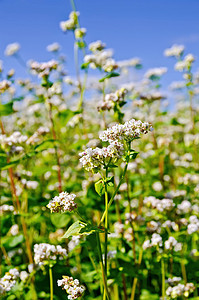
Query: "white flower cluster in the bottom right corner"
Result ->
[[166, 283, 195, 299]]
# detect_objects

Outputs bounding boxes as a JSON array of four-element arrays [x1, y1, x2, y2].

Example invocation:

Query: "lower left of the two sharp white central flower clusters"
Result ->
[[79, 141, 123, 171]]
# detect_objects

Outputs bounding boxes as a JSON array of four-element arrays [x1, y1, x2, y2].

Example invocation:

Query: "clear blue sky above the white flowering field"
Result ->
[[0, 0, 199, 81]]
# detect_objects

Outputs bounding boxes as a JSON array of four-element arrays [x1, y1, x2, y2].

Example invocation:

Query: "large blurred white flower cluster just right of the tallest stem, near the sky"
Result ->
[[84, 50, 118, 72]]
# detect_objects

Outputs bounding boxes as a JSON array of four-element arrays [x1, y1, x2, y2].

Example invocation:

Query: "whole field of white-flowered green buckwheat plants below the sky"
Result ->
[[0, 1, 199, 300]]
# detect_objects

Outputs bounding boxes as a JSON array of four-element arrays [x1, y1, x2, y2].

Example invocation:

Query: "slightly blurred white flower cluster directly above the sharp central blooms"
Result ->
[[98, 88, 127, 110]]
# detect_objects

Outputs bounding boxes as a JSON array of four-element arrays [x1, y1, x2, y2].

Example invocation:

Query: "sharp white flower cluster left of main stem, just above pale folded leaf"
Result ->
[[46, 192, 77, 213]]
